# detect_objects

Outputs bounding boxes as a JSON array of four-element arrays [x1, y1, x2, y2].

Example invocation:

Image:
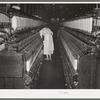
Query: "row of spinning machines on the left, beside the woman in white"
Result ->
[[0, 12, 46, 89]]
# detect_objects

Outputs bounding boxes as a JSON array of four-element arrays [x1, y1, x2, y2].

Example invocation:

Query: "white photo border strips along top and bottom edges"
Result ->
[[0, 0, 100, 100]]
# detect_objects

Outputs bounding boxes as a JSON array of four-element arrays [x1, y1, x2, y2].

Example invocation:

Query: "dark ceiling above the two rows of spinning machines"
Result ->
[[0, 3, 100, 21]]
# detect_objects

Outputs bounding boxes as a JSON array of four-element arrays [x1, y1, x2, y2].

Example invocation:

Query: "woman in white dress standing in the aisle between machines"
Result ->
[[40, 27, 54, 60]]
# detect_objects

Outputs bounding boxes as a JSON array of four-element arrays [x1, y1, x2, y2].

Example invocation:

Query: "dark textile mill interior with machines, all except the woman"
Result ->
[[0, 3, 100, 89]]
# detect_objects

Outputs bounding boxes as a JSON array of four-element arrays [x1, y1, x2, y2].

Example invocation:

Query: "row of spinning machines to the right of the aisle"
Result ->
[[58, 16, 100, 89]]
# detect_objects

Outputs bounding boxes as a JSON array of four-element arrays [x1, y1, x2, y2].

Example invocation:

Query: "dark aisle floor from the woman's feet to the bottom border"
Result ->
[[37, 57, 65, 89]]
